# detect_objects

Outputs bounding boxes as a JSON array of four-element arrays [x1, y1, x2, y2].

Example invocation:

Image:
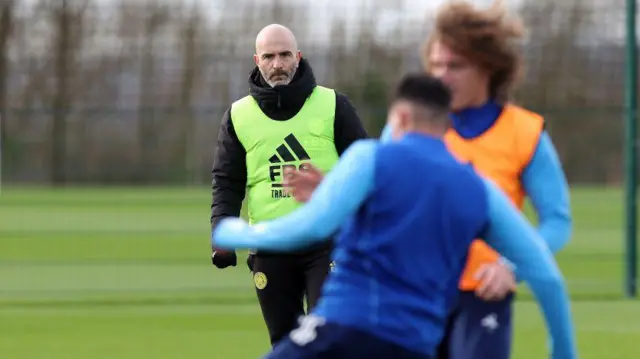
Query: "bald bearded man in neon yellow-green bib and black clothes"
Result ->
[[211, 24, 367, 345]]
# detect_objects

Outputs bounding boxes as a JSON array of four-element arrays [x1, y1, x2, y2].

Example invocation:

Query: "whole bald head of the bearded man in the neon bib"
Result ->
[[253, 24, 302, 87]]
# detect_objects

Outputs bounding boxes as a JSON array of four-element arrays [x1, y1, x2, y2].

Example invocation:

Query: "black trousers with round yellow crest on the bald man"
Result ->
[[250, 243, 331, 345]]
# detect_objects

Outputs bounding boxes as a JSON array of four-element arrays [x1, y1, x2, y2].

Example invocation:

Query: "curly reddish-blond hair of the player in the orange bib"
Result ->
[[422, 0, 524, 101]]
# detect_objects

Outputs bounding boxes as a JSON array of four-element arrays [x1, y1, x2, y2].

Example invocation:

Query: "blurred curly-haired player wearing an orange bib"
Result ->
[[422, 2, 572, 359]]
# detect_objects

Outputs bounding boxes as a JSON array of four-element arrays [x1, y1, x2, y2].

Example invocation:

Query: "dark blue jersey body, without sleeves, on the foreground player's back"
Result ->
[[316, 135, 488, 355]]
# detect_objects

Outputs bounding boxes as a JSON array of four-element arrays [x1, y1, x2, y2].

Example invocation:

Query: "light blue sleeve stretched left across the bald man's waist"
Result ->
[[211, 139, 377, 251]]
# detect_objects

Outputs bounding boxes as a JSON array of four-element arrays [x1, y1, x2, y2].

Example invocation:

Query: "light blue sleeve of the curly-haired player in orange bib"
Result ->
[[522, 132, 572, 253]]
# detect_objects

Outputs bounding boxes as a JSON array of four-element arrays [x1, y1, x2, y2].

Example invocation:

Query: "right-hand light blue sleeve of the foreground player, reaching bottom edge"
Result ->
[[483, 181, 577, 359]]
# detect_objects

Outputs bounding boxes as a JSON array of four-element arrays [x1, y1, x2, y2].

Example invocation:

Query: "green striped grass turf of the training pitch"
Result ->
[[0, 187, 640, 359]]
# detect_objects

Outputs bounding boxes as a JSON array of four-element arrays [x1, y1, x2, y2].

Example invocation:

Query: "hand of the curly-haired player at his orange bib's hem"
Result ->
[[475, 262, 516, 301]]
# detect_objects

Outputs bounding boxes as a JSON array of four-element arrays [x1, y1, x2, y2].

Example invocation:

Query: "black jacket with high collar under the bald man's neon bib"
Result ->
[[211, 59, 367, 228]]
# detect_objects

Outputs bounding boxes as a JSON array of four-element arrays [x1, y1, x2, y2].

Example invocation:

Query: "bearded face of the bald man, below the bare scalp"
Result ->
[[254, 37, 302, 87]]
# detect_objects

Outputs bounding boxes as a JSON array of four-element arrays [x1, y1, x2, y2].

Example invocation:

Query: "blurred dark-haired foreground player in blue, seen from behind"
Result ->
[[212, 74, 577, 359]]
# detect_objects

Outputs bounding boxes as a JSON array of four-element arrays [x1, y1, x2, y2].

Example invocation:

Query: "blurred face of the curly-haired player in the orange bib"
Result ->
[[428, 41, 489, 111]]
